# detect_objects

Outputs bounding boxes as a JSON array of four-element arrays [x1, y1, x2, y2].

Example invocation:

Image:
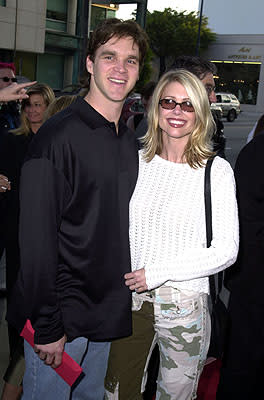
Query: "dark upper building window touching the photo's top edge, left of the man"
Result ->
[[46, 0, 68, 32]]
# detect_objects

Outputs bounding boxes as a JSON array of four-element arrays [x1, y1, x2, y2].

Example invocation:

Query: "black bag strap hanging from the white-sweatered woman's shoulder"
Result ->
[[204, 157, 223, 304]]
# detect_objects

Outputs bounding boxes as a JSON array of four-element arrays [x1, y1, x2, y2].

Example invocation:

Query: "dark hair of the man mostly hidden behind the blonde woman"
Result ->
[[169, 56, 217, 80]]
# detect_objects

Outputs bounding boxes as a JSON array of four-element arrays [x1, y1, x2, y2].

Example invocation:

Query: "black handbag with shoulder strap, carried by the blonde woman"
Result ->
[[204, 158, 228, 358]]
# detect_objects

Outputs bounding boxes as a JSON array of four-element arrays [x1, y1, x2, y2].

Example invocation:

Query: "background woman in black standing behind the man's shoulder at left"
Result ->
[[0, 83, 55, 400]]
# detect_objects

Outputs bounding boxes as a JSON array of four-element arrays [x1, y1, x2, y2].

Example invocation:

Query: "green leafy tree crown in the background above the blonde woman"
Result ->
[[146, 8, 216, 72]]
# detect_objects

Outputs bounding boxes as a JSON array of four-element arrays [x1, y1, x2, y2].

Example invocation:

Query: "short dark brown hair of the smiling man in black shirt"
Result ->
[[81, 18, 148, 88]]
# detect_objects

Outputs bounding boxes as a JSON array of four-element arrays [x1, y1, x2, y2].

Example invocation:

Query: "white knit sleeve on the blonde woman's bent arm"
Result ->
[[144, 162, 239, 290]]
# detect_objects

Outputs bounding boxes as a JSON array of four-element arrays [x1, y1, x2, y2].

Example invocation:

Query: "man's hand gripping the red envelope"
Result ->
[[34, 335, 67, 368]]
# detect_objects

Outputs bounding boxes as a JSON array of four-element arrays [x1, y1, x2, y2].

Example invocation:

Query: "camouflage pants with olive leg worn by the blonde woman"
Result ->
[[105, 286, 211, 400]]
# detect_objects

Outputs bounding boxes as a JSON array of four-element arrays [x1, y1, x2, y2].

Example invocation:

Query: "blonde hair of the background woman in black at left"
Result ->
[[10, 83, 55, 136]]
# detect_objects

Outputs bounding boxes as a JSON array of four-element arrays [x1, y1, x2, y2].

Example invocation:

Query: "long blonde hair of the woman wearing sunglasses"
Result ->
[[142, 69, 215, 168]]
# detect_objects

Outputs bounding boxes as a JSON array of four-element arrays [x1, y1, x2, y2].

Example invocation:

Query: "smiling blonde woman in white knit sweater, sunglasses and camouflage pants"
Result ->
[[105, 70, 239, 400]]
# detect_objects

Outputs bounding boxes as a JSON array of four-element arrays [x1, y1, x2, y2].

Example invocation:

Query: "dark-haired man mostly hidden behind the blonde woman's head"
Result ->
[[170, 56, 226, 158]]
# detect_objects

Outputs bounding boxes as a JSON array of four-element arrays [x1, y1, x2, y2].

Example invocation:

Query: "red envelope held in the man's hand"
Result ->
[[20, 319, 82, 386]]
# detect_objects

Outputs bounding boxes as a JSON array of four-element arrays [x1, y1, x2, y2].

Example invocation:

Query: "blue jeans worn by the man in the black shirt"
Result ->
[[22, 337, 110, 400]]
